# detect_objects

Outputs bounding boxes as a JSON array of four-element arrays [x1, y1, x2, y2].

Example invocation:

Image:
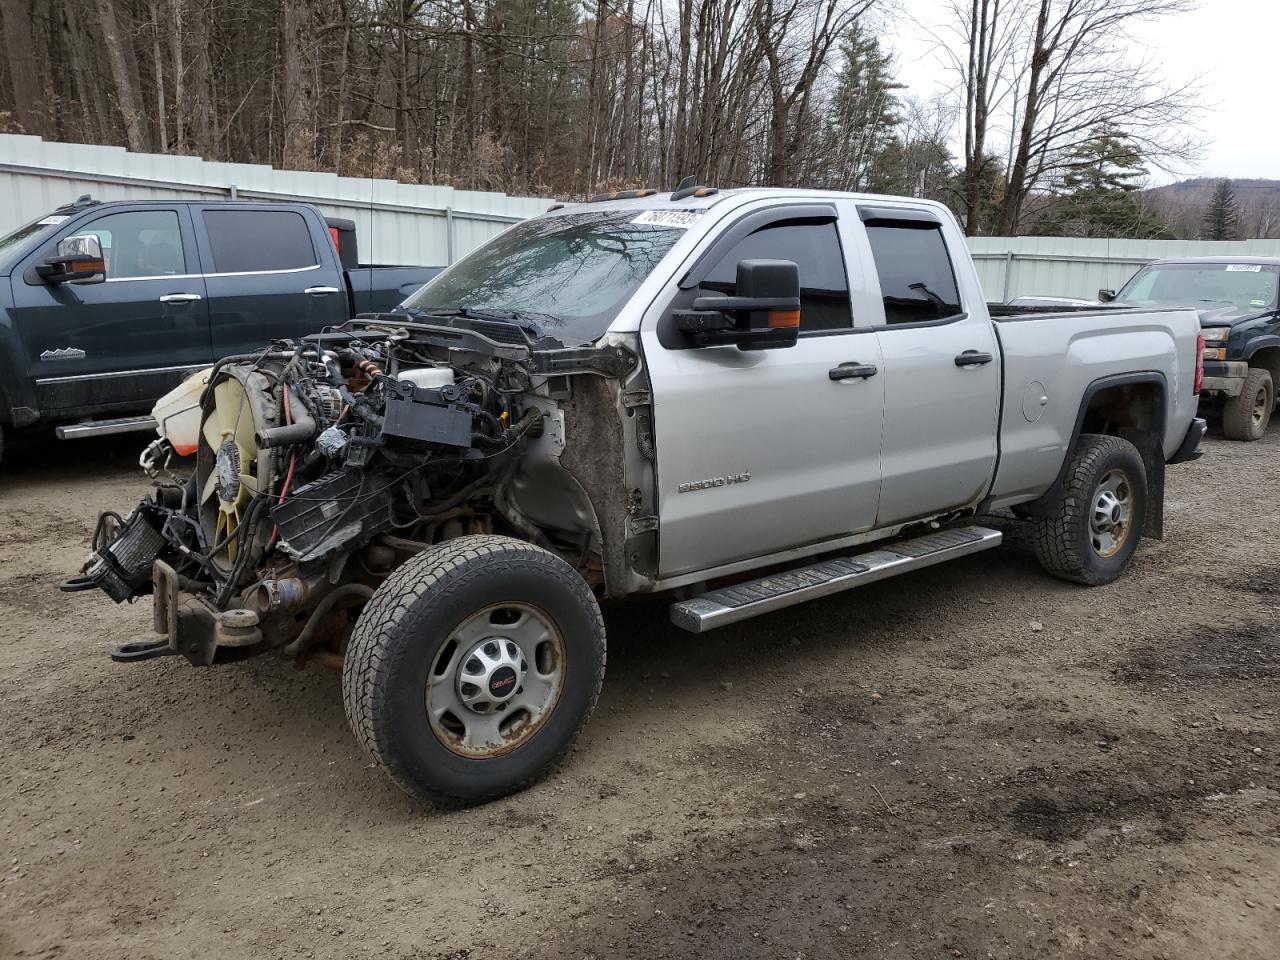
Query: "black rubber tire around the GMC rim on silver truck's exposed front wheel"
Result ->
[[342, 536, 605, 806]]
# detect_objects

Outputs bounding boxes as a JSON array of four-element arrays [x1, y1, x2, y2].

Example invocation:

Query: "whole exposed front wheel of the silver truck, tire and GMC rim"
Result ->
[[342, 536, 605, 806]]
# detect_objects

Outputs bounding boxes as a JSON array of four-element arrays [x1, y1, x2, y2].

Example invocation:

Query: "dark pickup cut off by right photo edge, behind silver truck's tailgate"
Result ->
[[1098, 256, 1280, 440]]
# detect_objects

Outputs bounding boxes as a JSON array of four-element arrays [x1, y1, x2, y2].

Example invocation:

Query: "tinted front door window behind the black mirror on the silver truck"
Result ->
[[700, 223, 854, 332]]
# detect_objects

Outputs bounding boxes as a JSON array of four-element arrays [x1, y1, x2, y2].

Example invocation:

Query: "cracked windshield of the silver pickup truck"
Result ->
[[403, 210, 684, 346]]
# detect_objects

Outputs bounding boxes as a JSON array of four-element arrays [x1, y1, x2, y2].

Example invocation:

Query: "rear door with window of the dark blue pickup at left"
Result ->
[[192, 204, 349, 357]]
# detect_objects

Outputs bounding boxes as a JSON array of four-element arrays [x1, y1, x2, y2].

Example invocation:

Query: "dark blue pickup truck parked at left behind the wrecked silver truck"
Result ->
[[0, 197, 440, 463]]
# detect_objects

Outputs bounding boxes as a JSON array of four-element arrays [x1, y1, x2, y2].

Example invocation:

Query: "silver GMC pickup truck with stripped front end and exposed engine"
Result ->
[[64, 187, 1204, 804]]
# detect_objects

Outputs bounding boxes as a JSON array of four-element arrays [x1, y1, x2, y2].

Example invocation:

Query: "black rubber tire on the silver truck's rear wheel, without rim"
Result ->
[[1033, 434, 1147, 586]]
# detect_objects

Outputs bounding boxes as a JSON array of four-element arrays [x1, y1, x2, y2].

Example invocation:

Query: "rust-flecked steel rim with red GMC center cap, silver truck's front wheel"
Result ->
[[425, 603, 566, 760]]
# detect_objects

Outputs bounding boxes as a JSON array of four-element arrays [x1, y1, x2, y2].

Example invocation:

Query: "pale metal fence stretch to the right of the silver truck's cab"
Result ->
[[969, 237, 1280, 301]]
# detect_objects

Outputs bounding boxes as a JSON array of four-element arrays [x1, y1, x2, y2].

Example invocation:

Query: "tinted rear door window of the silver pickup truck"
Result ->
[[867, 221, 963, 324]]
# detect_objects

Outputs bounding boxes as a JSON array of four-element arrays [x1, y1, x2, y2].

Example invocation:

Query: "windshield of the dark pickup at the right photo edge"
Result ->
[[1116, 264, 1280, 311]]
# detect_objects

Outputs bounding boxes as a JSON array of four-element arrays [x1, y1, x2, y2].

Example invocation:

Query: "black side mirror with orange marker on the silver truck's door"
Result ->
[[675, 260, 800, 349]]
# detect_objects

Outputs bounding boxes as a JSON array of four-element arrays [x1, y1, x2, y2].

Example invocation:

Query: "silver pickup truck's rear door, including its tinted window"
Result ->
[[859, 205, 1000, 526]]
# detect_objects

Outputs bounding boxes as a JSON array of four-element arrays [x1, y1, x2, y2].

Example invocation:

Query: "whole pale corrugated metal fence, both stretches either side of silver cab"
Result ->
[[10, 134, 1280, 293]]
